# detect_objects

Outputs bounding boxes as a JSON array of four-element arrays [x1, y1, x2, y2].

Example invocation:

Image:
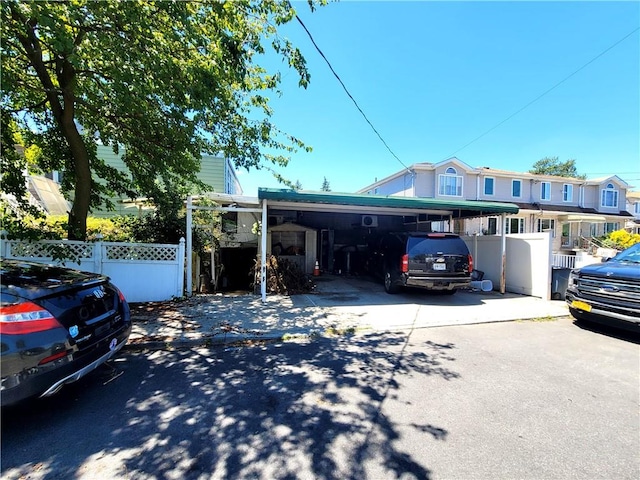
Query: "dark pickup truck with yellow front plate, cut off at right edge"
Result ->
[[565, 243, 640, 332]]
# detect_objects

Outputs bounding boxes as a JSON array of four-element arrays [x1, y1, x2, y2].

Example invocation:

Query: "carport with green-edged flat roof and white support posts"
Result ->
[[258, 188, 519, 301]]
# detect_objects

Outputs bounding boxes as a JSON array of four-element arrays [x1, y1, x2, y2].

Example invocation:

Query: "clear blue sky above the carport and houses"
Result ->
[[238, 1, 640, 195]]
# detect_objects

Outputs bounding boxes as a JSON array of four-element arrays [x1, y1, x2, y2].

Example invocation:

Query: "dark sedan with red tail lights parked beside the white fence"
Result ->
[[0, 260, 131, 406]]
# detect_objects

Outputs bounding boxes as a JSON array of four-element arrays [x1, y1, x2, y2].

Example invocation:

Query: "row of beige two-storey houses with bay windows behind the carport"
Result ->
[[358, 158, 633, 253]]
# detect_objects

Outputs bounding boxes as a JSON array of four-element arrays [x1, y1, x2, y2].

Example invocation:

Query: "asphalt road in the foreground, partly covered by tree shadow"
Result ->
[[1, 319, 640, 479]]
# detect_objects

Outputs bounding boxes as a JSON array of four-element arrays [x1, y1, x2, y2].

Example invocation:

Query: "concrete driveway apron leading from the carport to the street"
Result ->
[[128, 275, 569, 348]]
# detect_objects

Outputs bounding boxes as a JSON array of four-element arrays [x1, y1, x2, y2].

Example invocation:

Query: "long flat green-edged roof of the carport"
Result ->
[[258, 188, 519, 218]]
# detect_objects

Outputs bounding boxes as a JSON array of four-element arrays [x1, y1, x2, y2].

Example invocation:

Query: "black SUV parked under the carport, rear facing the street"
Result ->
[[369, 232, 473, 294]]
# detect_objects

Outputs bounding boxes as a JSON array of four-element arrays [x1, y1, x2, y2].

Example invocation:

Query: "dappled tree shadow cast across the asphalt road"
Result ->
[[2, 333, 459, 479]]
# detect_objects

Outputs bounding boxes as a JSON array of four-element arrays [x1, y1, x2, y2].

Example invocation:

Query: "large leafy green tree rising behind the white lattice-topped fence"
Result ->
[[0, 0, 324, 239]]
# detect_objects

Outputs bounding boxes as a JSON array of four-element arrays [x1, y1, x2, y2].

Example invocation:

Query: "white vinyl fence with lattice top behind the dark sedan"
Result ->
[[0, 239, 185, 302]]
